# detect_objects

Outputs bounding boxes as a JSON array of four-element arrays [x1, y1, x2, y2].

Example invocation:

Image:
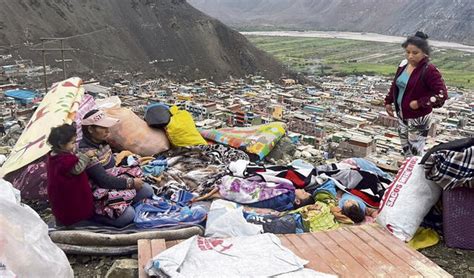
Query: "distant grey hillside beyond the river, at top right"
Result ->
[[188, 0, 474, 45]]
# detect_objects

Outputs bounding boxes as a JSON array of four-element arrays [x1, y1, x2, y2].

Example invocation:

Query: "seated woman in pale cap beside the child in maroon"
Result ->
[[79, 110, 153, 227]]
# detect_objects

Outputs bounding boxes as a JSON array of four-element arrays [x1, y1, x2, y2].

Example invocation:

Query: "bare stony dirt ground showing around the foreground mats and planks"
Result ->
[[28, 203, 474, 278]]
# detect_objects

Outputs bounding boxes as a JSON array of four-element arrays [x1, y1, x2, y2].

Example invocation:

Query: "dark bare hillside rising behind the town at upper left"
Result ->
[[0, 0, 282, 80]]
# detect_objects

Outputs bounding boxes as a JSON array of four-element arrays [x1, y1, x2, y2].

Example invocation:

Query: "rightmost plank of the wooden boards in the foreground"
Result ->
[[362, 226, 452, 277]]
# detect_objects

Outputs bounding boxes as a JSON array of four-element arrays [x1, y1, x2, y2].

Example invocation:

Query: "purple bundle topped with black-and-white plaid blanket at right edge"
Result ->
[[421, 137, 474, 250]]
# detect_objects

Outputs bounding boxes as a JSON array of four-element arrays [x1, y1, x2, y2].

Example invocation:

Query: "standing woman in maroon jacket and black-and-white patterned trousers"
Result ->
[[385, 31, 448, 157]]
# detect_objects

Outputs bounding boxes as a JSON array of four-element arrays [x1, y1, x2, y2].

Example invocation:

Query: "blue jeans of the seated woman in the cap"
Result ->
[[94, 183, 153, 228]]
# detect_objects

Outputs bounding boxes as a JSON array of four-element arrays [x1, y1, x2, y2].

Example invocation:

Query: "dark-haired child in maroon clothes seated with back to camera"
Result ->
[[47, 124, 95, 226]]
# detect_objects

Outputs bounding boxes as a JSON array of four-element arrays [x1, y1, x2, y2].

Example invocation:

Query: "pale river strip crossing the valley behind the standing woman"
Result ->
[[240, 31, 474, 53]]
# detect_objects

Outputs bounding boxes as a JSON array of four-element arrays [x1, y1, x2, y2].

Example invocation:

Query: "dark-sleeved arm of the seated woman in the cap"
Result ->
[[86, 163, 129, 190]]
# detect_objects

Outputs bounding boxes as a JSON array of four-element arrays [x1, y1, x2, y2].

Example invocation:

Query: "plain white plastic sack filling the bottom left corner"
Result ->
[[0, 179, 73, 278]]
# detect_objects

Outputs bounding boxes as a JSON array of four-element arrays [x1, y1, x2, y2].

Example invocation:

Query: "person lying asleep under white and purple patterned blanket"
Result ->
[[193, 174, 314, 211]]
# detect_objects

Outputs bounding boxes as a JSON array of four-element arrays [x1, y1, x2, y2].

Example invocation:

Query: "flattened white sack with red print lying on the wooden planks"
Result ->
[[145, 234, 334, 278]]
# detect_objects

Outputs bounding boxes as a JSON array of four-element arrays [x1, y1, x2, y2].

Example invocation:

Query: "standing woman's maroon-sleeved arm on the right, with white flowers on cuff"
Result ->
[[418, 64, 448, 108]]
